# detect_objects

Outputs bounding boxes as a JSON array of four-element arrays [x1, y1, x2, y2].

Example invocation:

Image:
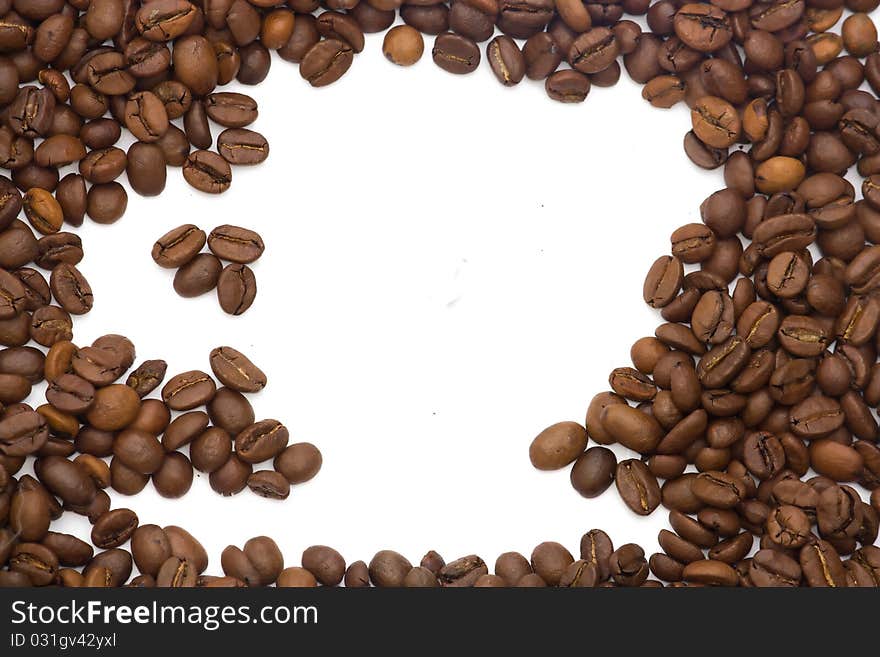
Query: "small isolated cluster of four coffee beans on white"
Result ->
[[152, 224, 265, 315]]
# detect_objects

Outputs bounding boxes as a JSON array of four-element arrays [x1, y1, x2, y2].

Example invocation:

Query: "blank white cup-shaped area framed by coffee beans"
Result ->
[[46, 24, 744, 574]]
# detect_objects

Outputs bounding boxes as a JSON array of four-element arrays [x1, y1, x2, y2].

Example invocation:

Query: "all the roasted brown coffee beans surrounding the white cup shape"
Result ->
[[0, 0, 880, 587]]
